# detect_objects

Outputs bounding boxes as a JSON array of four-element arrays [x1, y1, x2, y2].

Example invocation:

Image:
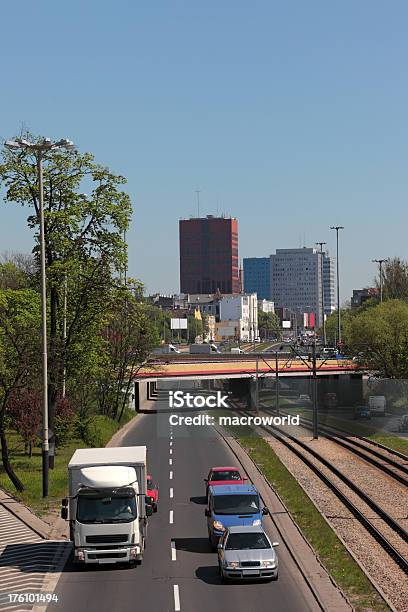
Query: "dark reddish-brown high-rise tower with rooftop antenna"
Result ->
[[179, 215, 240, 294]]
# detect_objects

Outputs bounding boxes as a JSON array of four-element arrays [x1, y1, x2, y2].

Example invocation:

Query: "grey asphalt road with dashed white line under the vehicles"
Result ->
[[52, 390, 320, 612]]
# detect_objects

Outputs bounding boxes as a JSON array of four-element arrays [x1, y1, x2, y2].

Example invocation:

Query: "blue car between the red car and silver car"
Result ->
[[205, 484, 268, 550]]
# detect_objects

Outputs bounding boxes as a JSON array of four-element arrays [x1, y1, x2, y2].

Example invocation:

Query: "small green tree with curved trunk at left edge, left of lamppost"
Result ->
[[0, 289, 41, 491]]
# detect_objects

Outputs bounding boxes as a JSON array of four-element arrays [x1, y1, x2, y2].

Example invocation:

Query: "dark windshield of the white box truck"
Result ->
[[77, 491, 137, 523]]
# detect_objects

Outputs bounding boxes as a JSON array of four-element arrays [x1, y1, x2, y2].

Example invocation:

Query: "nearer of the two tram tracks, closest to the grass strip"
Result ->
[[233, 410, 408, 575]]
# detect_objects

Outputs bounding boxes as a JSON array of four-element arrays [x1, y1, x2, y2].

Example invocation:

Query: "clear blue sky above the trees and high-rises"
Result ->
[[0, 0, 408, 299]]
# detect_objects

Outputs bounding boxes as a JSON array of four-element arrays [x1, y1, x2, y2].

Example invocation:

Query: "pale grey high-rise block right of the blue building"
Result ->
[[271, 247, 326, 326]]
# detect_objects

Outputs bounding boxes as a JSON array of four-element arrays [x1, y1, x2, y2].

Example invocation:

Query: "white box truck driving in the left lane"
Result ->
[[61, 446, 152, 564]]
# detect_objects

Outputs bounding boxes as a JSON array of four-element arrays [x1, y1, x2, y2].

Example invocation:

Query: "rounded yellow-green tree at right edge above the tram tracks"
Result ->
[[348, 300, 408, 378]]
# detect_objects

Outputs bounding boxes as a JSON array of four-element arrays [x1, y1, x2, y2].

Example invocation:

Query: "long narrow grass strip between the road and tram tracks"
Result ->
[[222, 420, 390, 612]]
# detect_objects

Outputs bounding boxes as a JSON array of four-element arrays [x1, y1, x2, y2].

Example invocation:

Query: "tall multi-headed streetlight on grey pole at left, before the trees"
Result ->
[[5, 138, 74, 497]]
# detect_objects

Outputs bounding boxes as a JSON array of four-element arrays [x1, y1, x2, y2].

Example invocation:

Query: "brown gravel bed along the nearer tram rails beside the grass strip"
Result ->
[[261, 431, 408, 612]]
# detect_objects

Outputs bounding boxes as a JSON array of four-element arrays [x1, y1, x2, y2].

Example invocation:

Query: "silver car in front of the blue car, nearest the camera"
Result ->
[[218, 525, 279, 581]]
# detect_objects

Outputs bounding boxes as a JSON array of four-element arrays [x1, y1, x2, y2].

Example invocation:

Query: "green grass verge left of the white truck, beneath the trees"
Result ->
[[0, 412, 134, 516]]
